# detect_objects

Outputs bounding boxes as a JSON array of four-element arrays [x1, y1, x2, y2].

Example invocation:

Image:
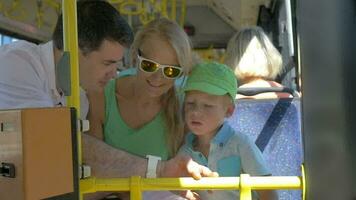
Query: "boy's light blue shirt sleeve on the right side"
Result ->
[[238, 134, 271, 176]]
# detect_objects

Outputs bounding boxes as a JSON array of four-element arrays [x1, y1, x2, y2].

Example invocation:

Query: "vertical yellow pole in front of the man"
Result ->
[[62, 0, 83, 199]]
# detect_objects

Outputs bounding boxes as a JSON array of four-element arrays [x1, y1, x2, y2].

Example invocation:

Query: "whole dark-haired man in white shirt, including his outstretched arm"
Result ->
[[0, 1, 215, 198]]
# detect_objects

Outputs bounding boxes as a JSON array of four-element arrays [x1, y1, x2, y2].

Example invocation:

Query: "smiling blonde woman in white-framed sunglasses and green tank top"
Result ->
[[89, 18, 195, 199]]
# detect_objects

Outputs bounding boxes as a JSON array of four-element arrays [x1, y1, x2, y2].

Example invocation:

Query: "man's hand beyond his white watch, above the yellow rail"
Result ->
[[158, 154, 219, 180]]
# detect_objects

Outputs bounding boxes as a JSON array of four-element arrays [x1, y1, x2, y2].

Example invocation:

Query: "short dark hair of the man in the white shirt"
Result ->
[[52, 0, 133, 54]]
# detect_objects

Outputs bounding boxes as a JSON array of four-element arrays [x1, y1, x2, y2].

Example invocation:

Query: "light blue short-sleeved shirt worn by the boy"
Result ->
[[180, 122, 270, 200]]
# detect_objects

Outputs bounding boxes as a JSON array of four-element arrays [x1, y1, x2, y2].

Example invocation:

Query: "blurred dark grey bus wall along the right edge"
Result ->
[[297, 0, 356, 200]]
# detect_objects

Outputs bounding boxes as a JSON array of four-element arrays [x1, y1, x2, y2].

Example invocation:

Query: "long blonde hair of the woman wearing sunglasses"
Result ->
[[130, 18, 192, 156]]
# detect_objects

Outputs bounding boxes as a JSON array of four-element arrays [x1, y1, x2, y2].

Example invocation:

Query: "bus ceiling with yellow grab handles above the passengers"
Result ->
[[0, 0, 276, 48]]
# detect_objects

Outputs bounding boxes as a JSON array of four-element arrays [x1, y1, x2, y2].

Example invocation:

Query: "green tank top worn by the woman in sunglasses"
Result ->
[[104, 79, 169, 160]]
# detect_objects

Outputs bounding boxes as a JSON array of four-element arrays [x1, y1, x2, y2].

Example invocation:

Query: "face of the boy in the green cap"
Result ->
[[184, 91, 234, 136]]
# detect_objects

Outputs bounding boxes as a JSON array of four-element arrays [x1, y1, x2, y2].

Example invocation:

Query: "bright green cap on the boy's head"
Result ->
[[183, 62, 237, 101]]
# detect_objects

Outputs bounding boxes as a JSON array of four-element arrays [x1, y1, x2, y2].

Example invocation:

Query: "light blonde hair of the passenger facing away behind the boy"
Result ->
[[225, 27, 282, 81]]
